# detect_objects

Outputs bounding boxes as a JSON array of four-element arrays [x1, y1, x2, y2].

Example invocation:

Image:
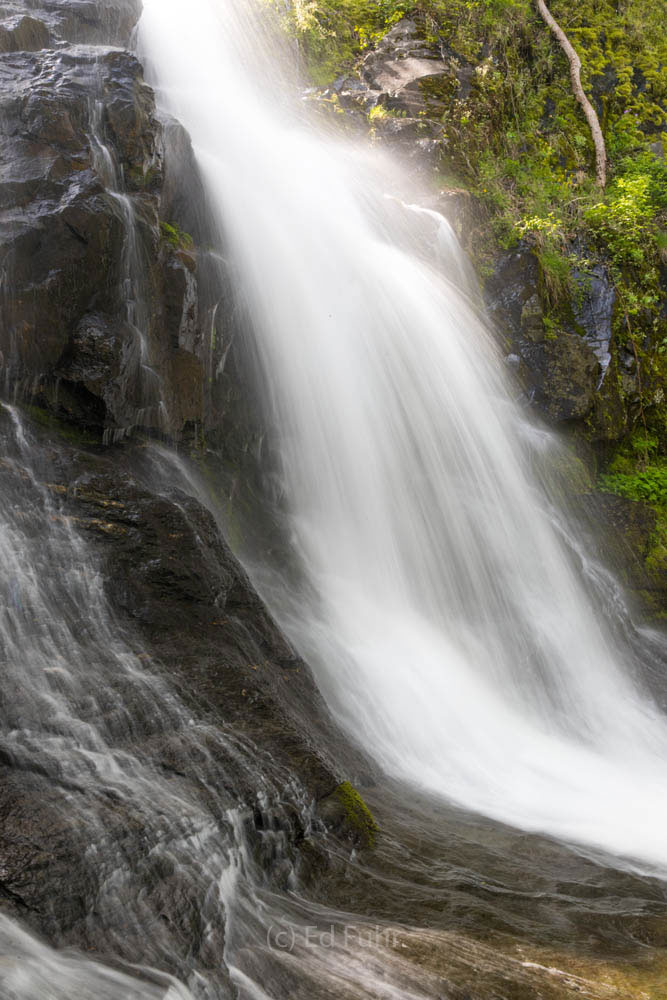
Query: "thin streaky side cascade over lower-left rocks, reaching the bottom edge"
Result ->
[[0, 403, 452, 1000]]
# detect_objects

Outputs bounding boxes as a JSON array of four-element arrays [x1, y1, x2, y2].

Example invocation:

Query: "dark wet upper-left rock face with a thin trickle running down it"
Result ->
[[0, 2, 236, 439]]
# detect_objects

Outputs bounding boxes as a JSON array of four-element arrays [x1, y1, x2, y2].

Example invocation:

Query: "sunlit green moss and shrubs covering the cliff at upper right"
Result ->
[[266, 0, 667, 442]]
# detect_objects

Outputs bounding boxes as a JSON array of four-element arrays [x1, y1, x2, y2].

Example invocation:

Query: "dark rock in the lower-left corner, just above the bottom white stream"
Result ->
[[0, 720, 235, 996]]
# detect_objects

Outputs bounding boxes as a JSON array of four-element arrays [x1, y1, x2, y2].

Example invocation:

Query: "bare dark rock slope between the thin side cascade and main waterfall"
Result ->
[[54, 456, 368, 799]]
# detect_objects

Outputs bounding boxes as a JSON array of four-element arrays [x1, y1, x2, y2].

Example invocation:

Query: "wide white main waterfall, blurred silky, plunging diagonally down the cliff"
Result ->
[[140, 0, 667, 871]]
